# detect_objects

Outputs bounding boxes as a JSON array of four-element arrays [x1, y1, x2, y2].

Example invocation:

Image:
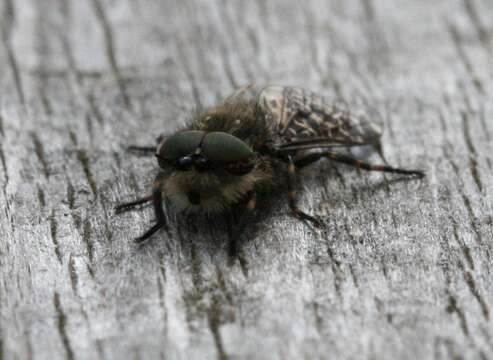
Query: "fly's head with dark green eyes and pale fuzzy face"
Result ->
[[156, 130, 255, 211]]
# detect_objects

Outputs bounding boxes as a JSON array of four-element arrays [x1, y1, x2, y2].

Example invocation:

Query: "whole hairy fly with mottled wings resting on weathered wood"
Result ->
[[116, 85, 424, 256]]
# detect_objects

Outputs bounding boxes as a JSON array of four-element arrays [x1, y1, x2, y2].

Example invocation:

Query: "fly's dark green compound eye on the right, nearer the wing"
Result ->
[[202, 131, 253, 164]]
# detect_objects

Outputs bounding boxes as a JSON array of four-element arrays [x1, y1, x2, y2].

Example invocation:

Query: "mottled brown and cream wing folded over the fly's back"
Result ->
[[259, 86, 381, 150]]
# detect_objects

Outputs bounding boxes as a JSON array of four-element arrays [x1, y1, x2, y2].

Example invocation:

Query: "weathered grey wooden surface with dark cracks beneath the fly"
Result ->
[[0, 0, 493, 359]]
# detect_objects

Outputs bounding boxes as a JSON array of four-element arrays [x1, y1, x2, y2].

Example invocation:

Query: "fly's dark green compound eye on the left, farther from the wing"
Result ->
[[158, 130, 205, 161]]
